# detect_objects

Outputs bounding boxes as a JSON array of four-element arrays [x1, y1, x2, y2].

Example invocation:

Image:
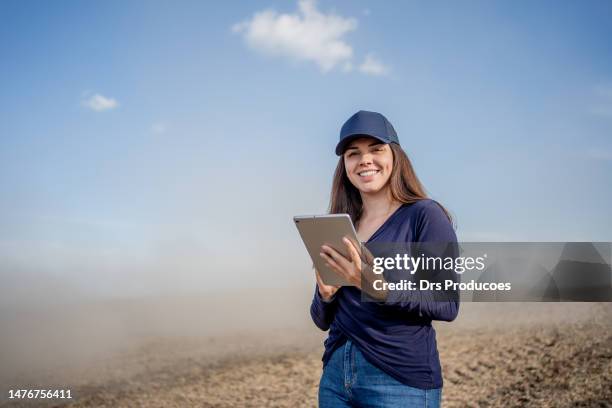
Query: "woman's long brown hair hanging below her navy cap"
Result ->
[[329, 143, 453, 223]]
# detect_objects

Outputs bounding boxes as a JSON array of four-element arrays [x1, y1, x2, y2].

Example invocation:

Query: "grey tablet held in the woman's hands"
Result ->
[[293, 214, 360, 286]]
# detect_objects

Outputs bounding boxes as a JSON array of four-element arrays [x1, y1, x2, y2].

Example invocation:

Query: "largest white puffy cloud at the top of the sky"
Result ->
[[232, 0, 357, 72]]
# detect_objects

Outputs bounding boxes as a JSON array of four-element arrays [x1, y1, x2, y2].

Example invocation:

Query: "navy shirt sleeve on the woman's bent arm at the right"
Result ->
[[384, 200, 459, 322]]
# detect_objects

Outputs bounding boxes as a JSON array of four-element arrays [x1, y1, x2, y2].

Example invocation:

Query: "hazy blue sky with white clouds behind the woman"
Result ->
[[0, 0, 612, 293]]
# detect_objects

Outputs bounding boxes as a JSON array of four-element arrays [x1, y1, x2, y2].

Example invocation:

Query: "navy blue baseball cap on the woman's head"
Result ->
[[336, 111, 399, 156]]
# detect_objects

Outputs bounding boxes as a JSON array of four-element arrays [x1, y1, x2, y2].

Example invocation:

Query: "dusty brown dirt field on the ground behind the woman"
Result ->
[[0, 303, 612, 407]]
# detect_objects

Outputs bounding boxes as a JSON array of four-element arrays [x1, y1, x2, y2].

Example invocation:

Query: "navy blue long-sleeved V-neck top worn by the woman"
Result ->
[[310, 199, 459, 389]]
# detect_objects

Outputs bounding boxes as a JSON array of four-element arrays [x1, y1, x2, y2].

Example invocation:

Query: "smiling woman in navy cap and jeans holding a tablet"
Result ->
[[310, 111, 459, 408]]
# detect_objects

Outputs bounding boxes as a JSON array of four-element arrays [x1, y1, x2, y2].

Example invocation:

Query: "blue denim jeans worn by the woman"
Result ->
[[319, 340, 442, 408]]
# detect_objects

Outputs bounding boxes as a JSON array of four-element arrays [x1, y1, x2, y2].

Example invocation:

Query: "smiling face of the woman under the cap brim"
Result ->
[[343, 137, 393, 193]]
